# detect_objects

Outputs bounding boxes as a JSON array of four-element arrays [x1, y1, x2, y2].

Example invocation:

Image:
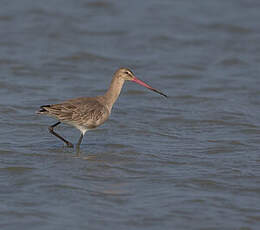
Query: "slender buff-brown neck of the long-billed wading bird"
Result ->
[[104, 75, 125, 111]]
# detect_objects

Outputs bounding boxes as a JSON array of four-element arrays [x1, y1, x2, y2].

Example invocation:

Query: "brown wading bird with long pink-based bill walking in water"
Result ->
[[37, 68, 167, 149]]
